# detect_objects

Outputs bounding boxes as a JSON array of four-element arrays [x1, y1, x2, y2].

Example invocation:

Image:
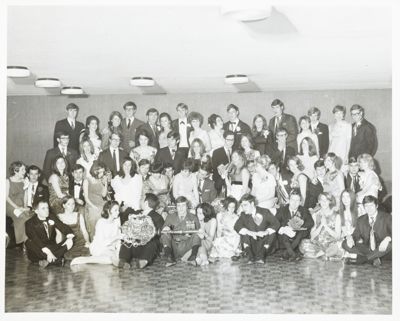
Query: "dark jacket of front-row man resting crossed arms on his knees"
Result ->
[[233, 206, 280, 233]]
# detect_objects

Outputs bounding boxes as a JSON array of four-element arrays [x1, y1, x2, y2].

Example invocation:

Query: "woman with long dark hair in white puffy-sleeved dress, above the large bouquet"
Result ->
[[111, 157, 143, 211]]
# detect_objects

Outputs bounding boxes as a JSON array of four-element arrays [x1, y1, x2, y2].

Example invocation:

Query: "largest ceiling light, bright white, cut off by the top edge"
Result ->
[[221, 1, 271, 22]]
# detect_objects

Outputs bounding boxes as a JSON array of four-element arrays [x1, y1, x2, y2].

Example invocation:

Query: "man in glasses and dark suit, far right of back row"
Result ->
[[349, 105, 378, 159]]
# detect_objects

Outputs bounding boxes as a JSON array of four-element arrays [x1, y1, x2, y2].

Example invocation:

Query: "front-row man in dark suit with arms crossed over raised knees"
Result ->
[[234, 194, 280, 263]]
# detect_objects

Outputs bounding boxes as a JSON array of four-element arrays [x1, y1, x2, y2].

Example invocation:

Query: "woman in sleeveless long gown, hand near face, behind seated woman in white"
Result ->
[[83, 161, 109, 240]]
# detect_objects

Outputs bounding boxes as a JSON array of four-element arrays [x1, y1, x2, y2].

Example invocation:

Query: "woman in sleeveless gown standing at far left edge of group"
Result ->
[[6, 161, 31, 244]]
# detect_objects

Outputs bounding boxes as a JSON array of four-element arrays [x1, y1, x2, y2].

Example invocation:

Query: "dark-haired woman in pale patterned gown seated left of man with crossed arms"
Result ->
[[209, 197, 240, 261]]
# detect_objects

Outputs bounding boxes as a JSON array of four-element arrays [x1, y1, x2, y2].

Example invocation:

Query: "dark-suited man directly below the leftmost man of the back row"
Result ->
[[43, 132, 79, 179]]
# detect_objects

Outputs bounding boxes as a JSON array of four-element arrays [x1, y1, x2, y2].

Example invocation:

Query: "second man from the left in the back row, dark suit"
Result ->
[[121, 101, 144, 154]]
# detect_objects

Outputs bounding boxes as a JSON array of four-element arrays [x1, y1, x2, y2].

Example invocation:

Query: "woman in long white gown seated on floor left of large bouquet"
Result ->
[[71, 201, 122, 265]]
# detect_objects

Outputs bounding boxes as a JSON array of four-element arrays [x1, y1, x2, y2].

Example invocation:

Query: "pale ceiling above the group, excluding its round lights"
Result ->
[[7, 3, 392, 95]]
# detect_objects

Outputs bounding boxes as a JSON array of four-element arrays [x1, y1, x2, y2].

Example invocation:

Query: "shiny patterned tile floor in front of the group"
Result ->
[[5, 250, 392, 314]]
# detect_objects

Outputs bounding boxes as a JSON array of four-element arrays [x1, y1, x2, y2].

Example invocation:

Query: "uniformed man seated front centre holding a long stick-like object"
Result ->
[[161, 196, 201, 266]]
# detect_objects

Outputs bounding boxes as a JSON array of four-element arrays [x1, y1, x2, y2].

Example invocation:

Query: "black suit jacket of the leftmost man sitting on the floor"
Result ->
[[25, 214, 72, 249]]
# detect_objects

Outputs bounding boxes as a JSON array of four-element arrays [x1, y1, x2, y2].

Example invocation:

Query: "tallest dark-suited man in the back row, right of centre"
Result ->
[[268, 99, 299, 153]]
